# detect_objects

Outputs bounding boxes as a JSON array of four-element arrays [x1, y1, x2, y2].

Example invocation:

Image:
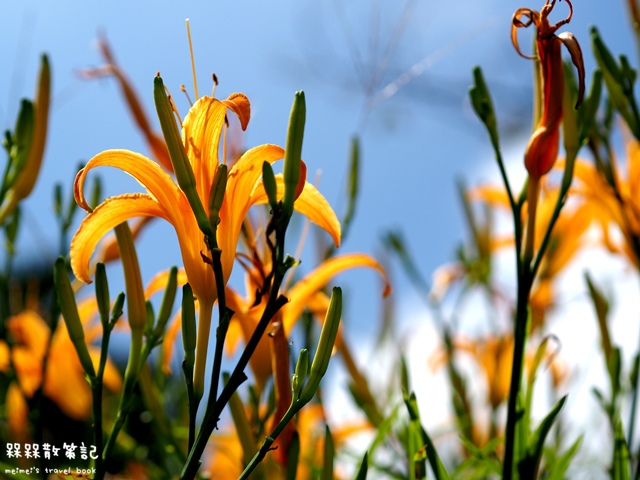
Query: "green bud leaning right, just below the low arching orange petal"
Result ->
[[300, 287, 342, 402]]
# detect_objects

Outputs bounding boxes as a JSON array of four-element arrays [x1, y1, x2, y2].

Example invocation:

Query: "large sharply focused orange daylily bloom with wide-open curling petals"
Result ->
[[71, 94, 340, 396]]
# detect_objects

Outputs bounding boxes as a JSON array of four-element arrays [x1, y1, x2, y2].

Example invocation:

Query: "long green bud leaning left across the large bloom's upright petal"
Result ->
[[153, 75, 213, 237]]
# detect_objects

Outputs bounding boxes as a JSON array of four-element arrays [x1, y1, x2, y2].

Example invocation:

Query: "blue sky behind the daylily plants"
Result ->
[[0, 0, 637, 342]]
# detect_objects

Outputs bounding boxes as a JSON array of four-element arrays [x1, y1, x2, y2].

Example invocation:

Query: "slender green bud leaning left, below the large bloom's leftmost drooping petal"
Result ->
[[53, 257, 96, 379]]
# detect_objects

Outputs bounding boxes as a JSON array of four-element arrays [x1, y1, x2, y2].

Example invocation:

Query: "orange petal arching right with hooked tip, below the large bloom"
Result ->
[[282, 253, 391, 333]]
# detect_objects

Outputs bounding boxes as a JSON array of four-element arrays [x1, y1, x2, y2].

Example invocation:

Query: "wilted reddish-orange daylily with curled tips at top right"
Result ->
[[511, 0, 585, 178]]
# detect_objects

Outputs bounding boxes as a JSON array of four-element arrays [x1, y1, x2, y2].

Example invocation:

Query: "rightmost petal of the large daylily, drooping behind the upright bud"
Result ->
[[251, 174, 342, 247]]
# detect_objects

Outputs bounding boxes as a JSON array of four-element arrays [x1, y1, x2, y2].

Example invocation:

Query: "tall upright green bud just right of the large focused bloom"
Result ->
[[282, 91, 307, 218]]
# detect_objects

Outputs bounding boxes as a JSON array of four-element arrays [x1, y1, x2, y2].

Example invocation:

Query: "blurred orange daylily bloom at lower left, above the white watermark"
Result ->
[[0, 299, 122, 427]]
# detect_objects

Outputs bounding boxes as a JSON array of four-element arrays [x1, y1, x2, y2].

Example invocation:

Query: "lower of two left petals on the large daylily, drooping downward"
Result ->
[[70, 192, 169, 283]]
